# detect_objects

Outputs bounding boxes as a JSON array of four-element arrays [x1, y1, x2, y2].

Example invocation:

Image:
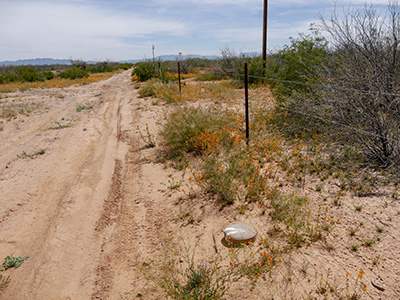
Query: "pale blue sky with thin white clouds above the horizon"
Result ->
[[0, 0, 394, 61]]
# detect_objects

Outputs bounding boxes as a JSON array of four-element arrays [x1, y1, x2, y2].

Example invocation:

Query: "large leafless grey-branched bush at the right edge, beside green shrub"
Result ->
[[314, 1, 400, 167]]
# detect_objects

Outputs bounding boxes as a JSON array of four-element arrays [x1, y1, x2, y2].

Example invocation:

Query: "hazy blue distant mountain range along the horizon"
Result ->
[[0, 52, 260, 66]]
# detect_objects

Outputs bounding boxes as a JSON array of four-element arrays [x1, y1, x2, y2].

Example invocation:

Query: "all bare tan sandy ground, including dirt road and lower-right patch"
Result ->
[[0, 71, 400, 300]]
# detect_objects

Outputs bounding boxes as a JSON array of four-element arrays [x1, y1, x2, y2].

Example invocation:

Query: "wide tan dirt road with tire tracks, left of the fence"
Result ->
[[0, 71, 167, 300]]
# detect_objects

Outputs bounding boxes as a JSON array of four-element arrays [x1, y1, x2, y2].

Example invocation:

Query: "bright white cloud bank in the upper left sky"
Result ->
[[0, 1, 184, 59]]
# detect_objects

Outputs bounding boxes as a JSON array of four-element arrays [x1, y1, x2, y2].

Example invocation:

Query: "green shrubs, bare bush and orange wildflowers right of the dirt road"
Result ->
[[132, 2, 400, 299]]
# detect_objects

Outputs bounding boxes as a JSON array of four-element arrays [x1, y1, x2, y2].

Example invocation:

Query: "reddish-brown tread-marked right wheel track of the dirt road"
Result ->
[[91, 91, 173, 299]]
